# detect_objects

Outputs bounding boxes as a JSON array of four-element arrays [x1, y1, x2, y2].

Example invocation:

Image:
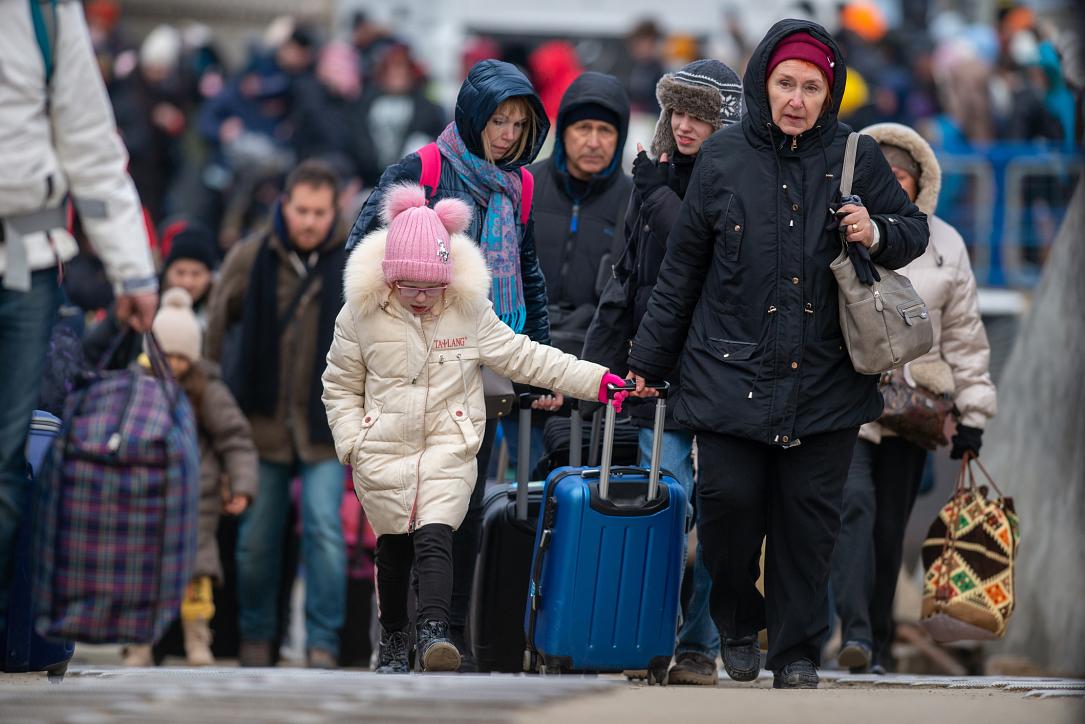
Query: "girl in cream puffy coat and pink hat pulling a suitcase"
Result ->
[[322, 183, 625, 673]]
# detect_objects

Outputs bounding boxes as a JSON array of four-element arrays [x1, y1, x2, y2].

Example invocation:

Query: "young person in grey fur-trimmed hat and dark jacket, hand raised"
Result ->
[[584, 60, 742, 686]]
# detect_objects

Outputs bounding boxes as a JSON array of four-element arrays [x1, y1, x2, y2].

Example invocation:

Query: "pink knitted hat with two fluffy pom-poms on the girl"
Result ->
[[381, 183, 471, 284]]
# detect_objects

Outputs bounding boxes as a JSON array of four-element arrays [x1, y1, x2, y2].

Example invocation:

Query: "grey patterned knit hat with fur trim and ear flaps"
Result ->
[[651, 59, 742, 158]]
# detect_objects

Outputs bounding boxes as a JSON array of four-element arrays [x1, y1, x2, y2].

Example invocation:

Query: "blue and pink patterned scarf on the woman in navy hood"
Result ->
[[437, 123, 527, 333]]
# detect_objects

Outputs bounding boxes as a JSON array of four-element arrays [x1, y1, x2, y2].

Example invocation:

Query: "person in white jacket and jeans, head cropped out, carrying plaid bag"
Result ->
[[0, 0, 158, 628]]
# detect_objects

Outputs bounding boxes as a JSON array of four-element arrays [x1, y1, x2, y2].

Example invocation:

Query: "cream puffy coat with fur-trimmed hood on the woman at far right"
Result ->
[[859, 123, 997, 442]]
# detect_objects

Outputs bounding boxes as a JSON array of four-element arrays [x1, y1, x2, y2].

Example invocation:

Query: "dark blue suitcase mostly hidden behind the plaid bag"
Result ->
[[2, 410, 75, 675]]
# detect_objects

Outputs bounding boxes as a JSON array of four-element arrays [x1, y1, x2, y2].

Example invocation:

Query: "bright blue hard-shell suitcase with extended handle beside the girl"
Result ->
[[524, 385, 688, 683]]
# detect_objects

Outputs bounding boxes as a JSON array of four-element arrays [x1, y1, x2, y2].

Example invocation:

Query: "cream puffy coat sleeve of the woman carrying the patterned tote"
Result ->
[[942, 244, 997, 430]]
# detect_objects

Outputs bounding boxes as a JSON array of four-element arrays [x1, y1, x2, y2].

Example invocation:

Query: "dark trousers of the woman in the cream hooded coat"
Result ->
[[832, 437, 927, 665]]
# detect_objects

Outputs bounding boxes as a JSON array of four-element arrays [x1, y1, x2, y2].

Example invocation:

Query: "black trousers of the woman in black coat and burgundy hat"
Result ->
[[697, 428, 858, 671]]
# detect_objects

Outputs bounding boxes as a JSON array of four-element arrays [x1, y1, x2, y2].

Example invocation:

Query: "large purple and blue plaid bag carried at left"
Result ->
[[35, 334, 200, 644]]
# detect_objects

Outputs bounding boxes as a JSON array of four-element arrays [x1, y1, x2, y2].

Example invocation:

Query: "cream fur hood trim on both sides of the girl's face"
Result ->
[[343, 228, 490, 316]]
